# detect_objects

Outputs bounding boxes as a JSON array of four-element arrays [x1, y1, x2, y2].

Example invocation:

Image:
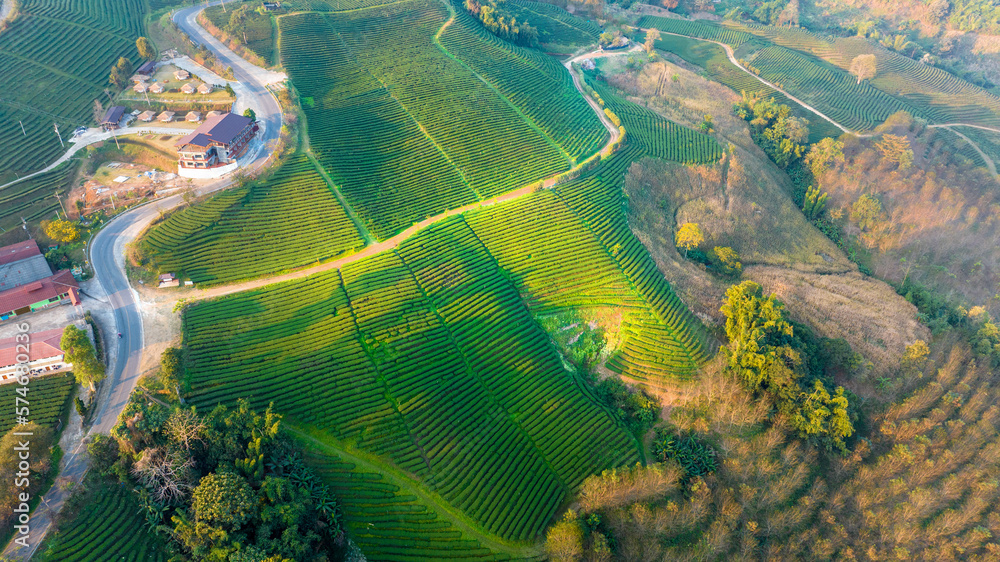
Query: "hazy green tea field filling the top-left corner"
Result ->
[[0, 0, 145, 183]]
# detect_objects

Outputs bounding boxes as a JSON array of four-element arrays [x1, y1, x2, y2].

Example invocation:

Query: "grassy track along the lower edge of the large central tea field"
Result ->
[[285, 423, 542, 558]]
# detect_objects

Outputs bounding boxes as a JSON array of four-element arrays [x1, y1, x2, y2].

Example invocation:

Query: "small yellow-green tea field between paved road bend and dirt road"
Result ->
[[140, 154, 364, 284]]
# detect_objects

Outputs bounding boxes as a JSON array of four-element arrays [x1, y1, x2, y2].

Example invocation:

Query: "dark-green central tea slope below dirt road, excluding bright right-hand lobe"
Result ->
[[185, 221, 637, 539]]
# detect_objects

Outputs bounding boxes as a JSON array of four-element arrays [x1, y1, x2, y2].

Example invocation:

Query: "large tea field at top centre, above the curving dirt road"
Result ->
[[280, 0, 606, 239]]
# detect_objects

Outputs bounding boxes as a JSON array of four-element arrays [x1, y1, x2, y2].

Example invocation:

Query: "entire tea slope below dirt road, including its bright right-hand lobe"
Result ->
[[178, 127, 708, 552]]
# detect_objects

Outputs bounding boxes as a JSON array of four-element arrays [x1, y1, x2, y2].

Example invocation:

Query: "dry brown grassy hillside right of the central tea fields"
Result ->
[[606, 62, 927, 371]]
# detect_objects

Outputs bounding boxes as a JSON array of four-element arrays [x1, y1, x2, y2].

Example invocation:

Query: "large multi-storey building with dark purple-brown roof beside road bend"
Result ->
[[176, 113, 257, 178]]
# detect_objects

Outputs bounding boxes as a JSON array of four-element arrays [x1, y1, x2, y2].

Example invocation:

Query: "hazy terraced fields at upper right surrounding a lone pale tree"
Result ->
[[638, 16, 1000, 133]]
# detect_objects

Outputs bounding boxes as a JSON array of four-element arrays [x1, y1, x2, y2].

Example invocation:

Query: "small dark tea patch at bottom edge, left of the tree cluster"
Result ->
[[38, 476, 167, 562]]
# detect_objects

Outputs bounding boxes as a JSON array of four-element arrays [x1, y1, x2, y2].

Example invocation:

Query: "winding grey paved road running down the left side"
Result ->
[[2, 2, 282, 560]]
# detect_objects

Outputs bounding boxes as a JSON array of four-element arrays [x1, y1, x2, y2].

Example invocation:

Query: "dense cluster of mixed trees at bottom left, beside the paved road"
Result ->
[[88, 394, 344, 562]]
